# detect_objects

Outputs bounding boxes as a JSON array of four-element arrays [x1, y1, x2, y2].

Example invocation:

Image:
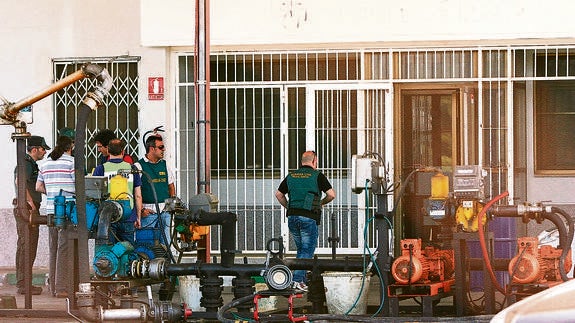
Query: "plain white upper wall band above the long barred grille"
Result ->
[[141, 0, 575, 46]]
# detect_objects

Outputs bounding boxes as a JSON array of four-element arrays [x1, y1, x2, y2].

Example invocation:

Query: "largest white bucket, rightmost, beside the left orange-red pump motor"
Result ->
[[321, 272, 371, 315]]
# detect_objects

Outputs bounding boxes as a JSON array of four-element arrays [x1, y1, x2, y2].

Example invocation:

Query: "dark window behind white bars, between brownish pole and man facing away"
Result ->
[[211, 88, 280, 178]]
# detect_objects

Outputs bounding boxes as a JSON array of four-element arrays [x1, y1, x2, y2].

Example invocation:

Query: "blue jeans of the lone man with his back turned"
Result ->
[[288, 215, 318, 283]]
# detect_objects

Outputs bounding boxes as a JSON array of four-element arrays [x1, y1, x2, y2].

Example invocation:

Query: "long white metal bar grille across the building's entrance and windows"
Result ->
[[176, 46, 575, 254]]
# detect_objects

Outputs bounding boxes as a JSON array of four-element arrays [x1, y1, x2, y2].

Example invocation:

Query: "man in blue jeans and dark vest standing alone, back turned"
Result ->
[[276, 151, 335, 291]]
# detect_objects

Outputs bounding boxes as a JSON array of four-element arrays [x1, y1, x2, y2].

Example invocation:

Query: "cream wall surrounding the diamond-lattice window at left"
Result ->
[[0, 0, 171, 266]]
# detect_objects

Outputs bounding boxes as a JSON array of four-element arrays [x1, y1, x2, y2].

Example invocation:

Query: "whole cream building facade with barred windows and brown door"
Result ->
[[0, 0, 575, 265]]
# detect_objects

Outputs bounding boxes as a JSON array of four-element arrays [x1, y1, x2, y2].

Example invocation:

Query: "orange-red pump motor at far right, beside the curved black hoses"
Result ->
[[508, 237, 572, 284]]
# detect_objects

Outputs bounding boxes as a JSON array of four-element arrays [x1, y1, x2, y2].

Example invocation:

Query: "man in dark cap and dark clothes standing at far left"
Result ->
[[13, 136, 50, 295]]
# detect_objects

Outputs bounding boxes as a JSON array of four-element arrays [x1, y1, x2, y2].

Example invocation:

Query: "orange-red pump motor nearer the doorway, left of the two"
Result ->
[[391, 239, 455, 285]]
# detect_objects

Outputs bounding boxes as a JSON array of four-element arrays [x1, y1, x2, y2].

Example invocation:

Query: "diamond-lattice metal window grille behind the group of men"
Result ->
[[53, 57, 140, 171]]
